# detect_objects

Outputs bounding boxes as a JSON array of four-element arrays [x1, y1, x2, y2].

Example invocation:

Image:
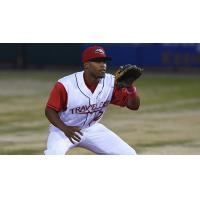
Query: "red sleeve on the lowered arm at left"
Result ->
[[46, 82, 67, 112]]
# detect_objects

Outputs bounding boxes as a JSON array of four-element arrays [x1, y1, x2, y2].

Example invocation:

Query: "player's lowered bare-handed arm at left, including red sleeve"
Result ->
[[45, 82, 82, 144]]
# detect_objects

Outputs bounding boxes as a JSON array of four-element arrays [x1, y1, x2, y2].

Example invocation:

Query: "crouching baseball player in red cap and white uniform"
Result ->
[[44, 46, 143, 155]]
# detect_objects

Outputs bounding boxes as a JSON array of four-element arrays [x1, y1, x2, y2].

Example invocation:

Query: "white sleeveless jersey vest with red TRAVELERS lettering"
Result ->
[[51, 71, 114, 130]]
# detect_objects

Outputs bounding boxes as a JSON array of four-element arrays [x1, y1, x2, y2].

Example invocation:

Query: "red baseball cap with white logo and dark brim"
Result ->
[[82, 46, 111, 63]]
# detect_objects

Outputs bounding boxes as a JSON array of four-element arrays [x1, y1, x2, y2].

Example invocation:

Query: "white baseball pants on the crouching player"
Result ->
[[44, 123, 136, 155]]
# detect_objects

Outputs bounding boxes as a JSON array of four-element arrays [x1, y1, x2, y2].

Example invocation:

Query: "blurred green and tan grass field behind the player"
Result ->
[[0, 71, 200, 155]]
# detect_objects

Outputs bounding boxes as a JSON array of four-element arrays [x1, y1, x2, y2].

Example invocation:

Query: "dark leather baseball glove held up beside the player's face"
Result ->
[[115, 64, 143, 87]]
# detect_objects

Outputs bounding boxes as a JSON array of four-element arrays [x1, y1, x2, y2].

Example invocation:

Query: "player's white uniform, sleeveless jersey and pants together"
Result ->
[[44, 71, 136, 155]]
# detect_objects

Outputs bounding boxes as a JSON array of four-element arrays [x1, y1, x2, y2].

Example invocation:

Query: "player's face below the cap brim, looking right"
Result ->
[[88, 60, 107, 79]]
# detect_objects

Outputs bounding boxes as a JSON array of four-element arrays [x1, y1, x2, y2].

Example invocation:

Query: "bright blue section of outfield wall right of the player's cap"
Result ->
[[82, 43, 200, 68]]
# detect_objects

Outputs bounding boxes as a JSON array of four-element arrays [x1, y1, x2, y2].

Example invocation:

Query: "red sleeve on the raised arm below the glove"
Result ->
[[111, 86, 137, 107]]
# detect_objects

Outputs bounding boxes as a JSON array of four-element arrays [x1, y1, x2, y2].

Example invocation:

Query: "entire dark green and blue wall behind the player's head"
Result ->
[[0, 43, 200, 71]]
